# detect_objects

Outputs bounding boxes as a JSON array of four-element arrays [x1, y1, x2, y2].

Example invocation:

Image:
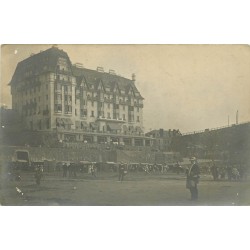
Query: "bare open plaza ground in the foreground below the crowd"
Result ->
[[0, 171, 250, 206]]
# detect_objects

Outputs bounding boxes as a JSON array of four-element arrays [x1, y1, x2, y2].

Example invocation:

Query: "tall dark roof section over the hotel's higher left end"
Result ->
[[10, 47, 72, 85]]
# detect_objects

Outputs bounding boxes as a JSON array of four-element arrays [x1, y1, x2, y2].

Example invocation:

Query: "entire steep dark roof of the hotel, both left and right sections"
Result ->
[[10, 47, 142, 98]]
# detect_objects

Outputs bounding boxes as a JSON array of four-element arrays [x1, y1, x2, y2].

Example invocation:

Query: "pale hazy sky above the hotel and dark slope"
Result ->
[[1, 45, 250, 132]]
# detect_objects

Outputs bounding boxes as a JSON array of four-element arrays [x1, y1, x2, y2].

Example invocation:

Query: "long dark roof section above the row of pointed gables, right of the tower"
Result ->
[[72, 65, 143, 99]]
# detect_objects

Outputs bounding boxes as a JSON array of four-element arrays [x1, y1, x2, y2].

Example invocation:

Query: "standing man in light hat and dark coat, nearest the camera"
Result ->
[[186, 157, 200, 200]]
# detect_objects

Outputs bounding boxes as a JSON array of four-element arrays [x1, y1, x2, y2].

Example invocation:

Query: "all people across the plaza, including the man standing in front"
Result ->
[[4, 157, 247, 201]]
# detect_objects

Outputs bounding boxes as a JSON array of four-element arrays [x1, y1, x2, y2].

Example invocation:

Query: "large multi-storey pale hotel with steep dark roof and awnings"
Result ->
[[10, 47, 152, 146]]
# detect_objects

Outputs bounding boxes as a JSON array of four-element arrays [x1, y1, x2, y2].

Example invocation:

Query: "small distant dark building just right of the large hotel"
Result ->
[[146, 129, 181, 151]]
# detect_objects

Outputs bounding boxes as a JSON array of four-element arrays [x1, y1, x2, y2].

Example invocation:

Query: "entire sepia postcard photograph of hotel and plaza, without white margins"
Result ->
[[0, 44, 250, 206]]
